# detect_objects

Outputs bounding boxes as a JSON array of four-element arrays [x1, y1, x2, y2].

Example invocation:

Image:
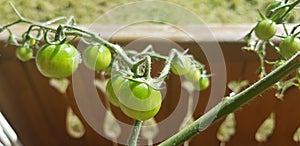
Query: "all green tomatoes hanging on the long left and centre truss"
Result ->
[[12, 26, 210, 120]]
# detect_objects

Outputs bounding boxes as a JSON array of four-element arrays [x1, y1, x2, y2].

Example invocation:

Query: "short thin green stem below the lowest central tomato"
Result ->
[[127, 120, 143, 146]]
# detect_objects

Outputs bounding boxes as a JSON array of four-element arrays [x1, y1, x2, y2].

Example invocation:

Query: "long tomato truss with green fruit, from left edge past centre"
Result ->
[[0, 3, 209, 145]]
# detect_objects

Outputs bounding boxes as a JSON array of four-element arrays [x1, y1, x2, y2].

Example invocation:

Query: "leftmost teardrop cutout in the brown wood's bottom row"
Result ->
[[66, 107, 85, 138]]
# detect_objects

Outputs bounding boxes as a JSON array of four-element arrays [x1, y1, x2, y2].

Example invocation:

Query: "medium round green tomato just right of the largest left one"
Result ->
[[83, 45, 111, 71]]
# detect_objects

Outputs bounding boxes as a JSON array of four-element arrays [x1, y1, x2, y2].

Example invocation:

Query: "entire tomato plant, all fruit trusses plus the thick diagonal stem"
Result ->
[[0, 0, 300, 146]]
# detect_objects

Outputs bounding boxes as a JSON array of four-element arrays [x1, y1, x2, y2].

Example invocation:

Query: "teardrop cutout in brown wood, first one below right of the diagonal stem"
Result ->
[[217, 113, 236, 142]]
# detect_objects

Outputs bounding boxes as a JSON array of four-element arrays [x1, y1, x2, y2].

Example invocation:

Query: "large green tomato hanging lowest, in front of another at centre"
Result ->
[[117, 80, 162, 120]]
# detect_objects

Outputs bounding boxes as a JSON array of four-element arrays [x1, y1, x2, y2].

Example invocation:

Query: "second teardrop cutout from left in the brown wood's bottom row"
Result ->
[[103, 111, 121, 139]]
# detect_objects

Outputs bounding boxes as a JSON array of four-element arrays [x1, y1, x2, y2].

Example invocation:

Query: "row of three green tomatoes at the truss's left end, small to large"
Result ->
[[16, 39, 112, 78]]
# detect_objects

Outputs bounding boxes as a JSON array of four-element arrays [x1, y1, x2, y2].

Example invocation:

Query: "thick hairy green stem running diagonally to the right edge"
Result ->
[[159, 52, 300, 146]]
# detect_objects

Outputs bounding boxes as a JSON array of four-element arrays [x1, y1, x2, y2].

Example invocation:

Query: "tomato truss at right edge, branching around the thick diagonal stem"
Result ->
[[243, 0, 300, 99]]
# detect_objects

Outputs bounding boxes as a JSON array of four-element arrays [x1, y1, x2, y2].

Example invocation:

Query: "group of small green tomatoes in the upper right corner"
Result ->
[[252, 1, 300, 59]]
